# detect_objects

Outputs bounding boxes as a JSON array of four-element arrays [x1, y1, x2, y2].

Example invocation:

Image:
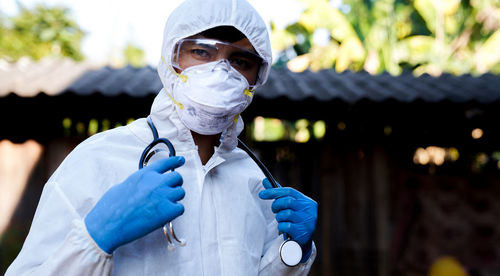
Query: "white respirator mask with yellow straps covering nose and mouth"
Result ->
[[172, 60, 253, 135]]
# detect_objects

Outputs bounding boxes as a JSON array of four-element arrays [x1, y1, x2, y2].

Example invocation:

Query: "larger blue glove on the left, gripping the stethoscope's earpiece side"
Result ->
[[85, 156, 185, 253]]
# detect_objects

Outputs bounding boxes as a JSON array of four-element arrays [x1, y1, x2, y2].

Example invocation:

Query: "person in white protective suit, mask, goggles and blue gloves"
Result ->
[[6, 0, 317, 275]]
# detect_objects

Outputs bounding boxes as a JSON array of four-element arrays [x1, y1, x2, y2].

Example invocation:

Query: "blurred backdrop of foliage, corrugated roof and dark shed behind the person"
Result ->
[[0, 0, 500, 276]]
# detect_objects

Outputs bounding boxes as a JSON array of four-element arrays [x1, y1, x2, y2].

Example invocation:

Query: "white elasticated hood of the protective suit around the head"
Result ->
[[158, 0, 272, 93]]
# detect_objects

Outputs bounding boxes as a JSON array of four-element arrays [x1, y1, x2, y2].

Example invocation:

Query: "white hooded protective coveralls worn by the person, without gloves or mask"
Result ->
[[6, 0, 316, 276]]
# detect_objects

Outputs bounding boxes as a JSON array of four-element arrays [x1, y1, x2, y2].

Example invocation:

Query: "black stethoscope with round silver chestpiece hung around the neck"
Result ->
[[139, 116, 302, 266]]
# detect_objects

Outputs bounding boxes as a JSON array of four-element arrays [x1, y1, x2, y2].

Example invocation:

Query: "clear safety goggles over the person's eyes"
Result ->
[[172, 38, 264, 82]]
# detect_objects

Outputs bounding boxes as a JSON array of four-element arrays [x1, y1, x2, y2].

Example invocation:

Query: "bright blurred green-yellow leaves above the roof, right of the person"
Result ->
[[272, 0, 500, 75]]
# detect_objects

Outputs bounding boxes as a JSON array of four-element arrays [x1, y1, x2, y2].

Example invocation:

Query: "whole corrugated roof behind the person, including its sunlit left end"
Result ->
[[0, 61, 500, 103]]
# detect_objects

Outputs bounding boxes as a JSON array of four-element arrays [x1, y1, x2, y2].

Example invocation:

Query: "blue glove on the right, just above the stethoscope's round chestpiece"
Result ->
[[259, 178, 318, 263]]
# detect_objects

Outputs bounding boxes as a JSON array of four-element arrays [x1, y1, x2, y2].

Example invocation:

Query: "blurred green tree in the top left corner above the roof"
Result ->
[[0, 4, 84, 61]]
